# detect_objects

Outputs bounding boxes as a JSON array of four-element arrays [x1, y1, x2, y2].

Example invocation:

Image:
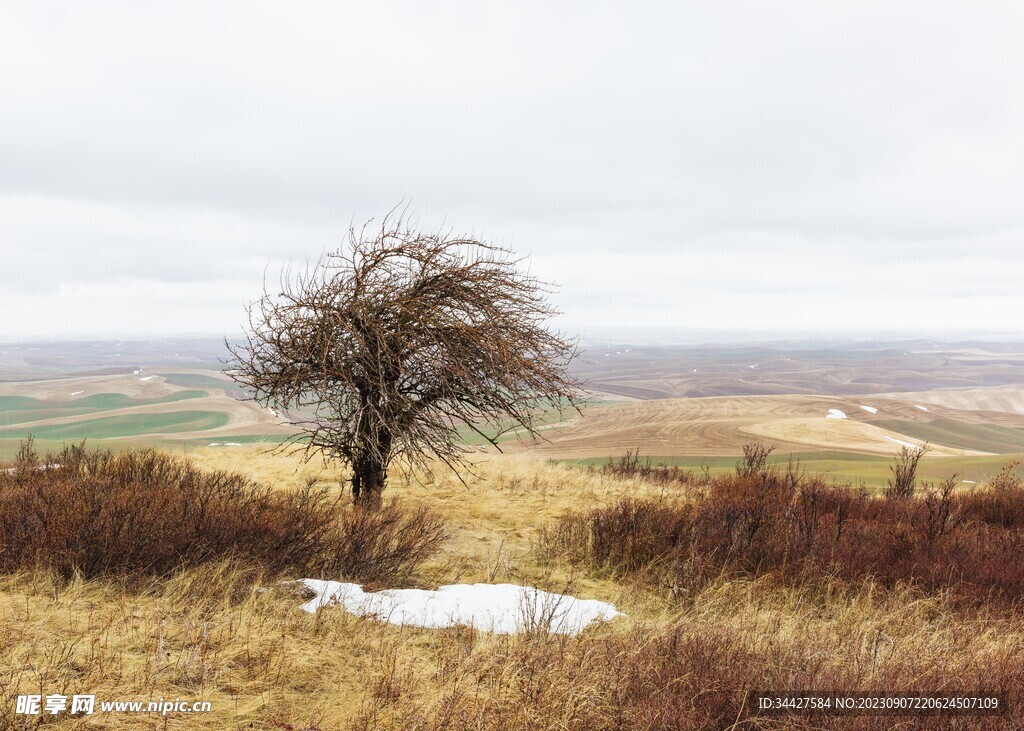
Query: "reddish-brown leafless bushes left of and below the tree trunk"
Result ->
[[0, 442, 445, 581]]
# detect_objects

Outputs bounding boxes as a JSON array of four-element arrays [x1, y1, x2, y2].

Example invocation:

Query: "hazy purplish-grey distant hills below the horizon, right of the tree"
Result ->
[[574, 339, 1024, 399]]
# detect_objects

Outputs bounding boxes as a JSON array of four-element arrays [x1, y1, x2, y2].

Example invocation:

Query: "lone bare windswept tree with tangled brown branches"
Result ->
[[227, 213, 583, 506]]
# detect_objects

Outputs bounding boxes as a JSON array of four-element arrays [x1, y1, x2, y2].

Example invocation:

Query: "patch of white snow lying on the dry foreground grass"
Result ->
[[298, 578, 621, 635]]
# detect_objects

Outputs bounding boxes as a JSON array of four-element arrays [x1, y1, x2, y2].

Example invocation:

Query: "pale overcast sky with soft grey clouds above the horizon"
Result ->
[[0, 0, 1024, 338]]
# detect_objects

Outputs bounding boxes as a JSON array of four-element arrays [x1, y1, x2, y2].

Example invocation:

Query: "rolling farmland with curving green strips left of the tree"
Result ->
[[0, 340, 294, 459]]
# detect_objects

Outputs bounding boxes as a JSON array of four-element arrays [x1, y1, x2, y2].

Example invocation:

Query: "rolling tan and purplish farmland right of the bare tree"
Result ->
[[506, 342, 1024, 485]]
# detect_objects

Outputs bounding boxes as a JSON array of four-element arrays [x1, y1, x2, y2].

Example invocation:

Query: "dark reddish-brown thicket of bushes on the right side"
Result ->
[[543, 449, 1024, 604]]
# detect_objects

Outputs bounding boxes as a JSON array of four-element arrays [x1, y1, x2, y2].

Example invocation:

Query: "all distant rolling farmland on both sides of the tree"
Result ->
[[6, 339, 1024, 484]]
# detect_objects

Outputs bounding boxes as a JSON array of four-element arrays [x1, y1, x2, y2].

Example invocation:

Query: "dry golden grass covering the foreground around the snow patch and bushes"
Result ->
[[0, 446, 1024, 731]]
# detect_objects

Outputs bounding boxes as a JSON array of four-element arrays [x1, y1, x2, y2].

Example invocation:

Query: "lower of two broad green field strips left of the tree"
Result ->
[[0, 411, 228, 440]]
